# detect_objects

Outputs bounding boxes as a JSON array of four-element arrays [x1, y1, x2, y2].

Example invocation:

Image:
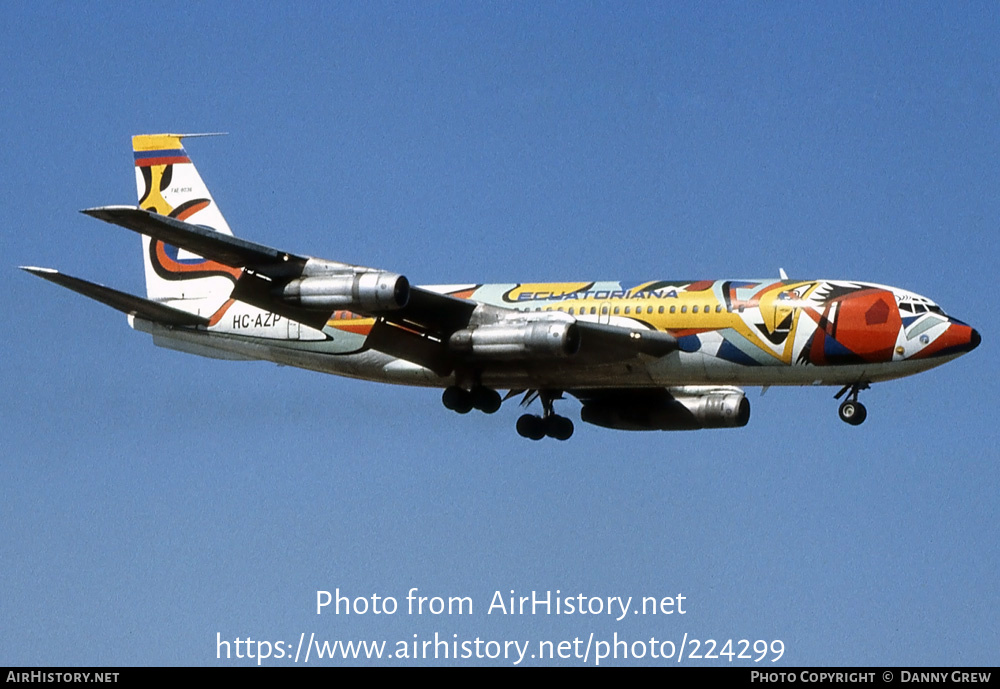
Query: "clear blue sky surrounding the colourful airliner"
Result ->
[[0, 3, 1000, 666]]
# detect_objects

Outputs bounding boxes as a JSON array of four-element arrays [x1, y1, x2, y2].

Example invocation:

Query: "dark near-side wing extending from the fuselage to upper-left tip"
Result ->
[[81, 206, 677, 375]]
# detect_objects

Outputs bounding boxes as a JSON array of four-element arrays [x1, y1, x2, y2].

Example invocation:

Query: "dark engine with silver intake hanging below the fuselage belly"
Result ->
[[580, 392, 750, 431]]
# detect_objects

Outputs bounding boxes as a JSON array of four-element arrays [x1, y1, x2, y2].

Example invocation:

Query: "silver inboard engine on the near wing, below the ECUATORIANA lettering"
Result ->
[[448, 321, 580, 360]]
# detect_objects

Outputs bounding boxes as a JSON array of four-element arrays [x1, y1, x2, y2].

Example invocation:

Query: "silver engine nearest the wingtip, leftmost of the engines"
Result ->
[[278, 271, 410, 313]]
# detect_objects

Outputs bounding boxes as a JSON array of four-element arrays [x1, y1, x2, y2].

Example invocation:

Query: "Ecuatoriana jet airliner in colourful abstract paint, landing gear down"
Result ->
[[22, 134, 981, 440]]
